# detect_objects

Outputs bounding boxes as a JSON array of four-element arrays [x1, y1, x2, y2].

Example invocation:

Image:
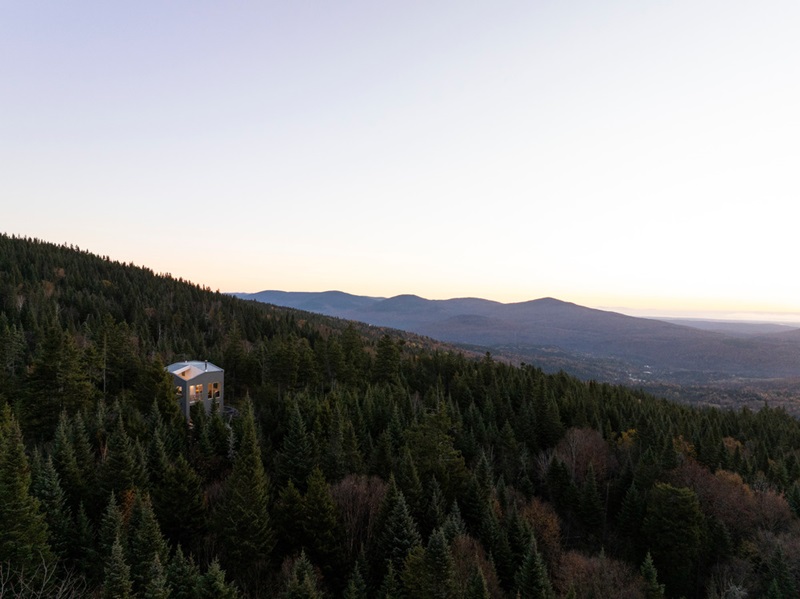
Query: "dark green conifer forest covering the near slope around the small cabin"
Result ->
[[0, 236, 800, 599]]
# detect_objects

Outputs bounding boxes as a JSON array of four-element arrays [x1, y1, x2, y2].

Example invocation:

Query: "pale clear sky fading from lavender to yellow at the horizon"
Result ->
[[0, 0, 800, 319]]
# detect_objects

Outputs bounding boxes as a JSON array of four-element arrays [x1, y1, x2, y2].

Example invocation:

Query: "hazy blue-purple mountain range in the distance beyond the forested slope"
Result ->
[[233, 291, 800, 392]]
